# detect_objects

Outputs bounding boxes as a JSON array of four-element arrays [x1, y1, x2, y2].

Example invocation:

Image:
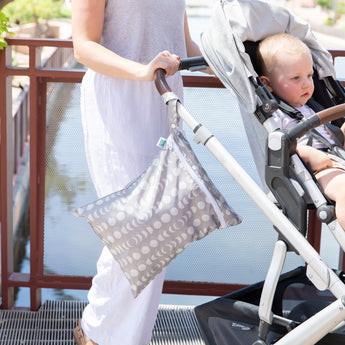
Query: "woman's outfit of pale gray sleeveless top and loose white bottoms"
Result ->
[[81, 0, 186, 345]]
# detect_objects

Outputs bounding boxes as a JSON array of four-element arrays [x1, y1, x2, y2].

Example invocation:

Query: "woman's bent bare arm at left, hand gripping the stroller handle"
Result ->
[[72, 0, 180, 81]]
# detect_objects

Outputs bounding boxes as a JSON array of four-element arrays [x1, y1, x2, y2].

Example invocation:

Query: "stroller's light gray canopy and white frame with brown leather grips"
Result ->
[[156, 0, 345, 345]]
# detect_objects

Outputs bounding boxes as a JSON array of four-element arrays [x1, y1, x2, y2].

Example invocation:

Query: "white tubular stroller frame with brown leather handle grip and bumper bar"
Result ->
[[155, 66, 345, 345]]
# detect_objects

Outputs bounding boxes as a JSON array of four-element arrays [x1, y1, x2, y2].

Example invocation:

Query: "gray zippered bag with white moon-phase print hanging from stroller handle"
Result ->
[[75, 99, 241, 296]]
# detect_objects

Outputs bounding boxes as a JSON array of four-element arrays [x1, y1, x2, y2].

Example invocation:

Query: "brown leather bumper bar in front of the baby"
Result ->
[[288, 103, 345, 139]]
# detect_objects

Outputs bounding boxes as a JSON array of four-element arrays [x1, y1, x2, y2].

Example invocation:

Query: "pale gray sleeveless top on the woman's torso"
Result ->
[[102, 0, 186, 62]]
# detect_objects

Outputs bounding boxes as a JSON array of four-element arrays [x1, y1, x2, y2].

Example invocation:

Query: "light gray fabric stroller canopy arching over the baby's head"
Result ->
[[201, 0, 335, 113]]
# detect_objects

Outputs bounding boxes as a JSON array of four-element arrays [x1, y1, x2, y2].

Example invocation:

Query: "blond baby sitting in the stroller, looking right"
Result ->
[[258, 34, 345, 230]]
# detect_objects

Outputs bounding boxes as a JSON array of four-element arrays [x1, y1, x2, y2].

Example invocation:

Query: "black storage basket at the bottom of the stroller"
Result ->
[[195, 267, 345, 345]]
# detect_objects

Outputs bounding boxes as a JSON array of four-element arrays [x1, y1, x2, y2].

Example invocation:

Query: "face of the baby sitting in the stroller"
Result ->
[[270, 53, 314, 108]]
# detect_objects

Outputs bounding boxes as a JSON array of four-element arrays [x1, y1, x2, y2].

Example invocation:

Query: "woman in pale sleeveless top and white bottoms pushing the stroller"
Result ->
[[72, 0, 201, 345]]
